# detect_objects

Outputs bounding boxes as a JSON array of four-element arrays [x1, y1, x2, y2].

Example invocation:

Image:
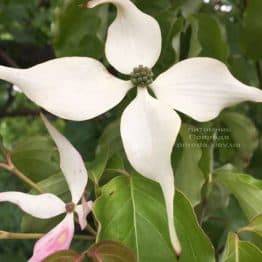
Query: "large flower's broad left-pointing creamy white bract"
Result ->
[[0, 57, 131, 121]]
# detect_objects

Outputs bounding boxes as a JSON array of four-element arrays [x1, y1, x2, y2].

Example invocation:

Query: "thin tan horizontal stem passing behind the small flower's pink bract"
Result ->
[[0, 231, 95, 240]]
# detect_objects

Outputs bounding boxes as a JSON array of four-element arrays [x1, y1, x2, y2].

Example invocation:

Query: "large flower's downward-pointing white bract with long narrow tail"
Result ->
[[121, 88, 181, 254]]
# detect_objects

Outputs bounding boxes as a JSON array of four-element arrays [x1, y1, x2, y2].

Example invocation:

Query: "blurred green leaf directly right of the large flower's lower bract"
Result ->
[[174, 125, 205, 206]]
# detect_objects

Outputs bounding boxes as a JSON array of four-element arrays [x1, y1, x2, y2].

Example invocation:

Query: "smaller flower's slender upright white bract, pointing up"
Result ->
[[42, 115, 88, 204]]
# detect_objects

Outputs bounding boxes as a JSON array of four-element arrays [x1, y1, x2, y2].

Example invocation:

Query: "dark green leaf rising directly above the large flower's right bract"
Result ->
[[189, 14, 229, 61]]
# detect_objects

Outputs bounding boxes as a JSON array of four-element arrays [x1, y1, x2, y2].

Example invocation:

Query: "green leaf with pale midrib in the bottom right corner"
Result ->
[[222, 233, 262, 262]]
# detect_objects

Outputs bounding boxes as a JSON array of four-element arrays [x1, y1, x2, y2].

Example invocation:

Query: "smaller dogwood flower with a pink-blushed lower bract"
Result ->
[[0, 117, 92, 262]]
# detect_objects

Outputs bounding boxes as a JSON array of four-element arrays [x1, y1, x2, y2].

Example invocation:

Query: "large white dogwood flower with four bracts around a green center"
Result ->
[[0, 0, 262, 254]]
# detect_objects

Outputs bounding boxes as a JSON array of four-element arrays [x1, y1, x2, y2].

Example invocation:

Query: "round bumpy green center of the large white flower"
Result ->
[[131, 65, 154, 87]]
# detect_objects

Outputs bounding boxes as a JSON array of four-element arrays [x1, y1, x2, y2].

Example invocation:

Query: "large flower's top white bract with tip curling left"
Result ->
[[88, 0, 162, 75]]
